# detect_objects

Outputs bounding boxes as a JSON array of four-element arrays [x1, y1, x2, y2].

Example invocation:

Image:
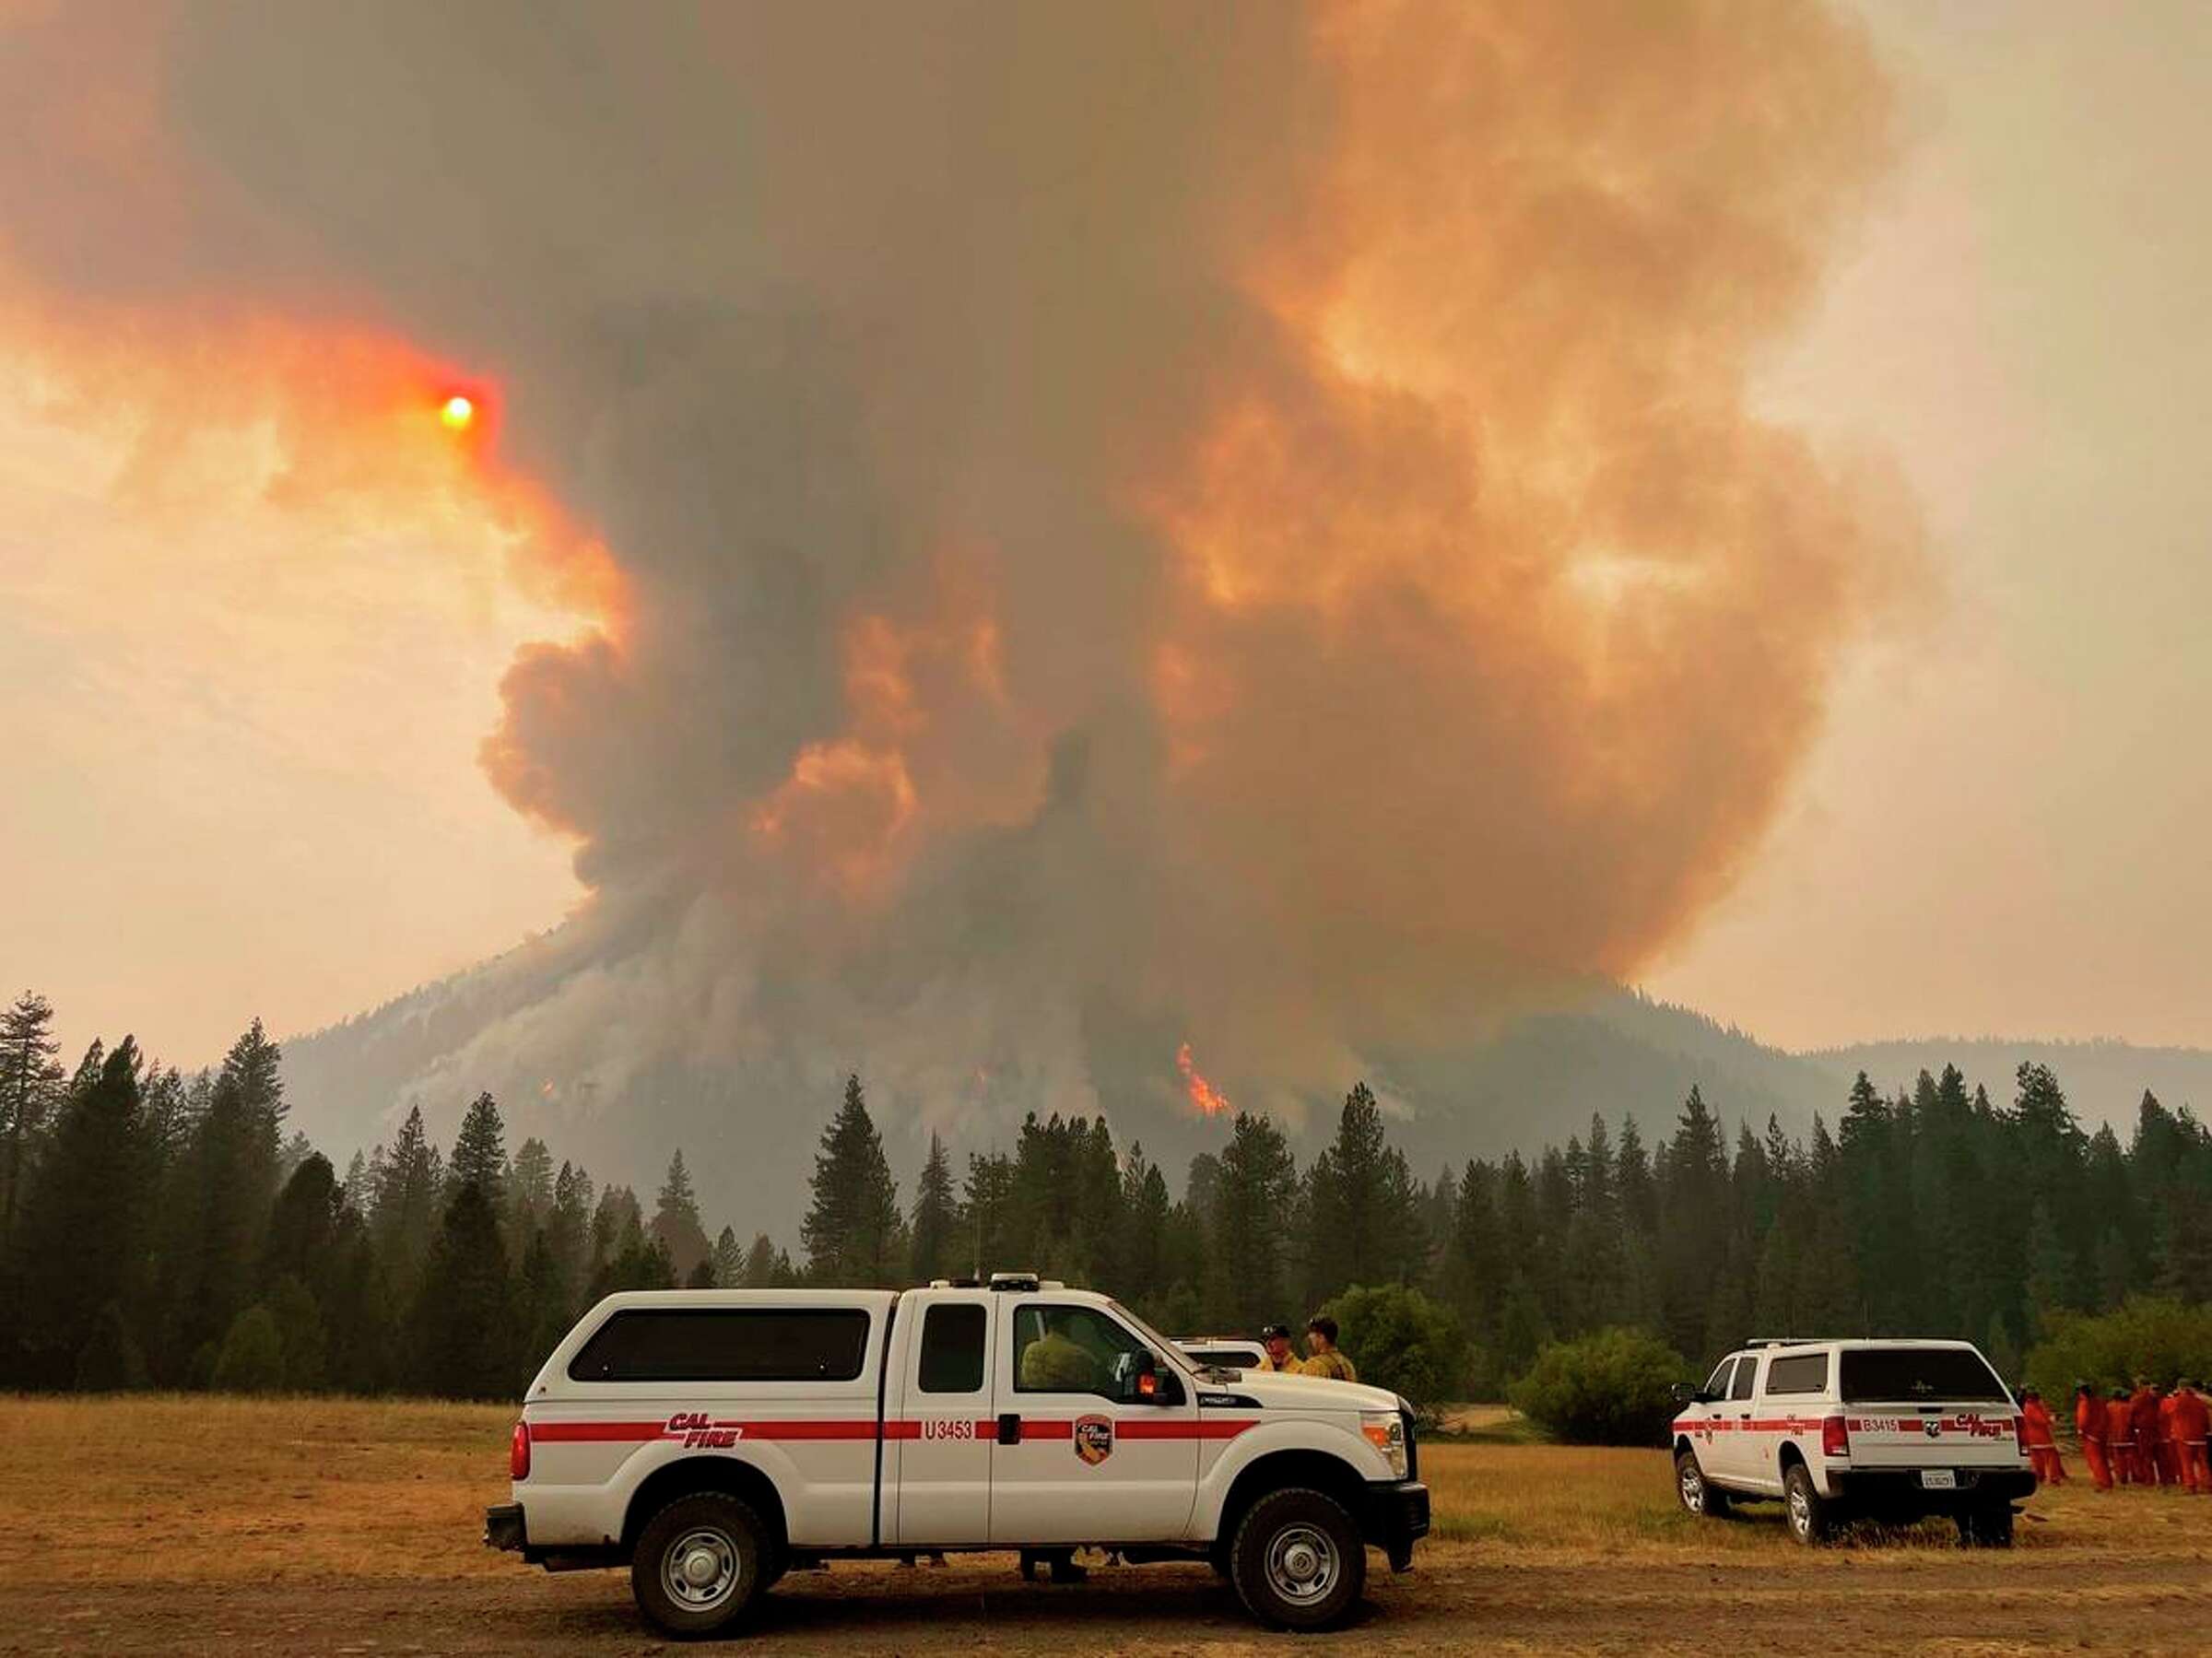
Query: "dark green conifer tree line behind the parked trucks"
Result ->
[[0, 994, 2212, 1397]]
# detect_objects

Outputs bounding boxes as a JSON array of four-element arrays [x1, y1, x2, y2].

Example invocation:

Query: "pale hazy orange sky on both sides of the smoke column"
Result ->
[[0, 0, 2212, 1064]]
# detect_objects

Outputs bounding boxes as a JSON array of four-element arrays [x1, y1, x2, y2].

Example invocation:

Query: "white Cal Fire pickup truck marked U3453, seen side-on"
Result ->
[[485, 1274, 1429, 1636]]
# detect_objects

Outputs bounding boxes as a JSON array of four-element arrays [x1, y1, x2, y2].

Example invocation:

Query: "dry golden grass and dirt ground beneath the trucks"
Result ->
[[0, 1399, 2212, 1658]]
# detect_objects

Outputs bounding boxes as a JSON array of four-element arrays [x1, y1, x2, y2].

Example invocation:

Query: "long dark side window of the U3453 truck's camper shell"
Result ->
[[569, 1307, 869, 1382]]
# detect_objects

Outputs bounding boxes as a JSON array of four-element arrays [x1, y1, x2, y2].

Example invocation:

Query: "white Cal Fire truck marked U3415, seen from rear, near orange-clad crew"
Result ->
[[1675, 1340, 2035, 1547]]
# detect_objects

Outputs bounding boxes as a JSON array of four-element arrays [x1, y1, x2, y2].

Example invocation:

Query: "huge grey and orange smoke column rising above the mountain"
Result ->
[[0, 0, 1913, 1194]]
